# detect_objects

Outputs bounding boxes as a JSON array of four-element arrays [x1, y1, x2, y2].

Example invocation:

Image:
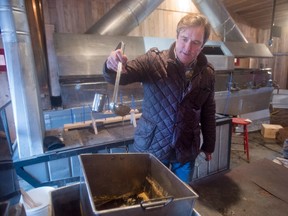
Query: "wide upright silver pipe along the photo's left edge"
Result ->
[[0, 0, 44, 158]]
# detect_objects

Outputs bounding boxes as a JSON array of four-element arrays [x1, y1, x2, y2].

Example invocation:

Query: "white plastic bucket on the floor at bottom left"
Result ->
[[20, 187, 55, 216]]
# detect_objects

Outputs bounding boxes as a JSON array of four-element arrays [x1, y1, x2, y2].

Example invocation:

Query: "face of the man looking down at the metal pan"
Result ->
[[175, 26, 204, 66]]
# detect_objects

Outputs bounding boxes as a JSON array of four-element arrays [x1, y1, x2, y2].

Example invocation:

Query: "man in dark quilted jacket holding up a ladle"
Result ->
[[103, 14, 216, 183]]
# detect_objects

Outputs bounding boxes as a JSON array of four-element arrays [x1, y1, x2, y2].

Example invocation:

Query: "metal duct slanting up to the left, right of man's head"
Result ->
[[192, 0, 248, 43]]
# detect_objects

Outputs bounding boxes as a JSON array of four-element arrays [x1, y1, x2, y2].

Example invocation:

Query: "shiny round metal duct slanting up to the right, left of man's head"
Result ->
[[86, 0, 164, 36]]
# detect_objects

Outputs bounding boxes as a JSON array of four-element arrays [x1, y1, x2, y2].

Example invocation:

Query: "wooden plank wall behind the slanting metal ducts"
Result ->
[[42, 0, 288, 89]]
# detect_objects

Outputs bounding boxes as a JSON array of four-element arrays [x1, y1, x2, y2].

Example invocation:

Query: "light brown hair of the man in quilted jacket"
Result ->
[[176, 14, 211, 45]]
